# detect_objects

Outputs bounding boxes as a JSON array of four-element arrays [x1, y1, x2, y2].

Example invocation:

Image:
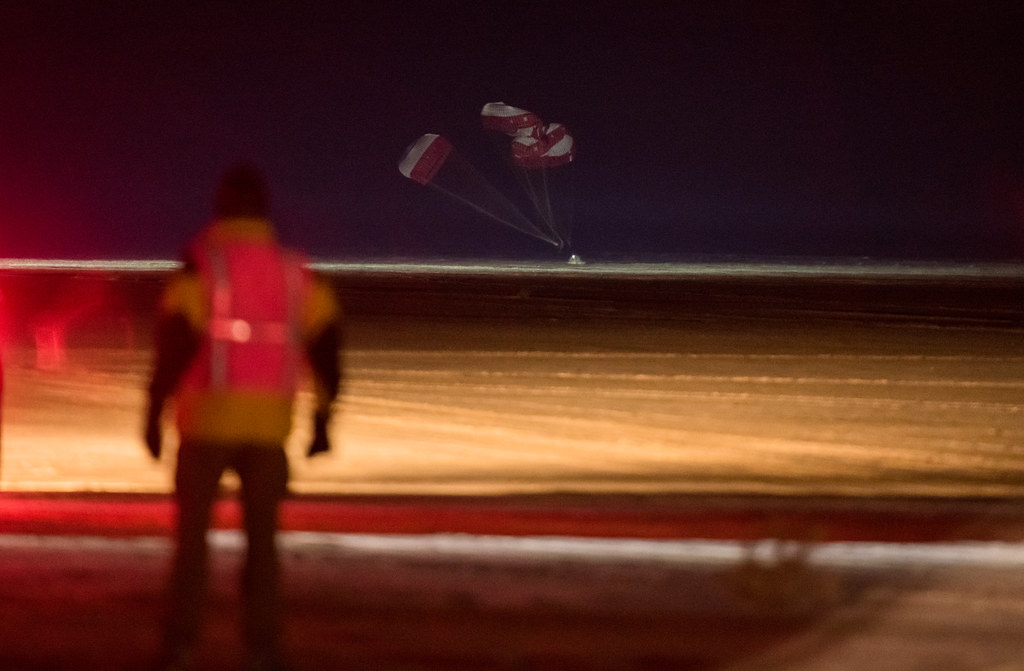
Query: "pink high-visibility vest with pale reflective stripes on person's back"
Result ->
[[182, 240, 310, 396]]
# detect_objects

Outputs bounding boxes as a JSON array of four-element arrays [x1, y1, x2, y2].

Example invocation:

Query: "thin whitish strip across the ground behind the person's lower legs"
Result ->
[[0, 530, 1024, 571]]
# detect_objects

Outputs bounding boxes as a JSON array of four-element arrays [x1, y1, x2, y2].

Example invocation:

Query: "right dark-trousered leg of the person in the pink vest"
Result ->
[[233, 447, 288, 668]]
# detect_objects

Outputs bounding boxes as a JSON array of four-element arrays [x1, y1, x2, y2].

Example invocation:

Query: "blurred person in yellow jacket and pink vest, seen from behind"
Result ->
[[144, 165, 341, 671]]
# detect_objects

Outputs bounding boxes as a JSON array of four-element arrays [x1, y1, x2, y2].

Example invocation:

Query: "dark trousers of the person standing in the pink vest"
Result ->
[[166, 442, 288, 654]]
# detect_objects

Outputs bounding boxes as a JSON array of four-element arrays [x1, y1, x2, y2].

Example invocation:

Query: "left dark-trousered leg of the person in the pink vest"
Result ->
[[164, 443, 227, 657]]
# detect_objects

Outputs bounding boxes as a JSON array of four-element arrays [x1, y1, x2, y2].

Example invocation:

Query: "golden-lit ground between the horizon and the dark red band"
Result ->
[[0, 260, 1024, 497]]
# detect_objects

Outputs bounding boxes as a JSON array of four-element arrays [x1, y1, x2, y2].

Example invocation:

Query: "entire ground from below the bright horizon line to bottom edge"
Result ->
[[0, 269, 1024, 671]]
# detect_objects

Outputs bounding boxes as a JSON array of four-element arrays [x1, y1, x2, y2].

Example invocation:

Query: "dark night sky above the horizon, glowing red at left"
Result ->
[[0, 0, 1024, 260]]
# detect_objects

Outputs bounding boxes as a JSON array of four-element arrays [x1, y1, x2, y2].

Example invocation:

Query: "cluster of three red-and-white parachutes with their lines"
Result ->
[[398, 102, 575, 249]]
